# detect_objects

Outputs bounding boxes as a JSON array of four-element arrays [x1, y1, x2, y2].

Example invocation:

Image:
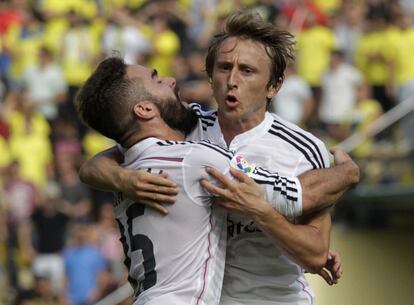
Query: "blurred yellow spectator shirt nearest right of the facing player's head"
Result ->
[[297, 25, 335, 87]]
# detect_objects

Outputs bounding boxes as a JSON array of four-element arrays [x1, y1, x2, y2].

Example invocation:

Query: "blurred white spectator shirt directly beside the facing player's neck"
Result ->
[[271, 75, 312, 124]]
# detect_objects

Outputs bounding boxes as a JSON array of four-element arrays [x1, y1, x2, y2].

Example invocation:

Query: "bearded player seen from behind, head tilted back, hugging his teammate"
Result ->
[[77, 57, 308, 305]]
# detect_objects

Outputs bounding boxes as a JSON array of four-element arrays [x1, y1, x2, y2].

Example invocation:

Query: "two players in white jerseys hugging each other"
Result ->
[[76, 12, 359, 305]]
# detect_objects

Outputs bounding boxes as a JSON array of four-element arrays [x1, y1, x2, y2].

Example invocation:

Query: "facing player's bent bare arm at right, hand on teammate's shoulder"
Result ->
[[201, 168, 331, 273]]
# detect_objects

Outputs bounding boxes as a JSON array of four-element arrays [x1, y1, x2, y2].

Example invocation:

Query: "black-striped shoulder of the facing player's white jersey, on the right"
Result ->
[[268, 113, 329, 168]]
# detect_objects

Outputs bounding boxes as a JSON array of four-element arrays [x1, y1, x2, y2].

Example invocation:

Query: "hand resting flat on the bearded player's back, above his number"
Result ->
[[121, 169, 178, 214]]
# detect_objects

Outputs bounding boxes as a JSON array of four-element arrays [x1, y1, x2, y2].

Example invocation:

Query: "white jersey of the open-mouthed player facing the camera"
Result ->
[[188, 104, 329, 305]]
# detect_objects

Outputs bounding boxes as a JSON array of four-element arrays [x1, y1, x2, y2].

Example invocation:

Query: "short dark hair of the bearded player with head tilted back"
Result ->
[[76, 56, 148, 144]]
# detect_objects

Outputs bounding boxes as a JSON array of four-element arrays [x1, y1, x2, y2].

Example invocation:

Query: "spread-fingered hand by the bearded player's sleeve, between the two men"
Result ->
[[200, 168, 266, 216]]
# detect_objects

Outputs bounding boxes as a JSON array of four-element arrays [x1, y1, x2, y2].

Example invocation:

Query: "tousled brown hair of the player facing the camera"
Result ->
[[205, 11, 295, 87]]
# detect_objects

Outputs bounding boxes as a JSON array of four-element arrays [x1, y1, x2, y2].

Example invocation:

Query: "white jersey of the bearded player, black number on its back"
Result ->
[[115, 138, 299, 305]]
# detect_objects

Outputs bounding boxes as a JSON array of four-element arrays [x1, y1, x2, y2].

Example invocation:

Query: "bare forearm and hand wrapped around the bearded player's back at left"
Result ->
[[79, 147, 178, 213]]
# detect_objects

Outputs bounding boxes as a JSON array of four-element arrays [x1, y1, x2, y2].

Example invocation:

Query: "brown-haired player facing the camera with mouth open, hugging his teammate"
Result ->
[[81, 12, 359, 305]]
